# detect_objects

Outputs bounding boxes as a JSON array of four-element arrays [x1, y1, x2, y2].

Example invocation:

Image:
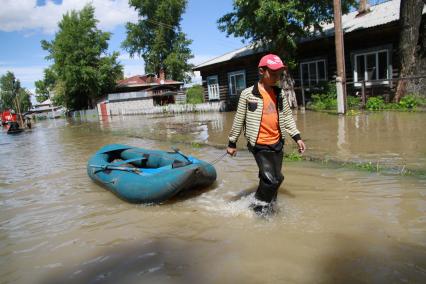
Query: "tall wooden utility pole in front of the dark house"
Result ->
[[333, 0, 346, 114]]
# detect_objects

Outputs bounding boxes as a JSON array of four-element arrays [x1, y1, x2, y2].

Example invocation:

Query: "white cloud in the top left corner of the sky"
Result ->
[[0, 0, 137, 34]]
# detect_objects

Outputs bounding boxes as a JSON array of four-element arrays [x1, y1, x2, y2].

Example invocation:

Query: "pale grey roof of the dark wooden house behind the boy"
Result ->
[[193, 0, 426, 70]]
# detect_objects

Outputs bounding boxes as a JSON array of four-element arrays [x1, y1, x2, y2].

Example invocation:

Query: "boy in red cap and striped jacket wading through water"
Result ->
[[226, 54, 306, 215]]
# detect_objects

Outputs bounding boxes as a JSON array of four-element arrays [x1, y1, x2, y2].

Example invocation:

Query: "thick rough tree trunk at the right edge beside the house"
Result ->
[[394, 0, 424, 102]]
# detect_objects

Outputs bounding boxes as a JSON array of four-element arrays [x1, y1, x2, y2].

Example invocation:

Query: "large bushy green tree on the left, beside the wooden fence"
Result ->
[[40, 5, 123, 110]]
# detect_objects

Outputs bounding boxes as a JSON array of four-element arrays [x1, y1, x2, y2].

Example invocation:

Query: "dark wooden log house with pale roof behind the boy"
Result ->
[[194, 0, 426, 105]]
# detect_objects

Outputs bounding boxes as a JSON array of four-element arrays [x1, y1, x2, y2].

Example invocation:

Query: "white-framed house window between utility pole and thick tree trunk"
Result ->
[[354, 49, 391, 86]]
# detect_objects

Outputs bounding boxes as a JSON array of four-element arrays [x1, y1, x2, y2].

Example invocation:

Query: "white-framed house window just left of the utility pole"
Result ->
[[300, 59, 327, 88]]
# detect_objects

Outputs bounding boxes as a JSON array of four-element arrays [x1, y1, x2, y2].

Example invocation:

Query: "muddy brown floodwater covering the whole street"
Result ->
[[0, 112, 426, 283]]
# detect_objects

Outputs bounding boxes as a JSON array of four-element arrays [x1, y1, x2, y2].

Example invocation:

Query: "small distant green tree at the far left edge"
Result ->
[[0, 71, 31, 112]]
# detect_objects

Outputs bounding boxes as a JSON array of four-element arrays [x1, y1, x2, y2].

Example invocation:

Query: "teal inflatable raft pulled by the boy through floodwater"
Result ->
[[87, 144, 216, 203]]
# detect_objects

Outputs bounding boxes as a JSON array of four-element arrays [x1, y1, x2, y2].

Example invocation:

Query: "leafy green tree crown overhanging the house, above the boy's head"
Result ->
[[218, 0, 356, 62]]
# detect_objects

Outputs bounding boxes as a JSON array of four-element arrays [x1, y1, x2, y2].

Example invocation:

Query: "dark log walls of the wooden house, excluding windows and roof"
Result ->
[[200, 19, 412, 107]]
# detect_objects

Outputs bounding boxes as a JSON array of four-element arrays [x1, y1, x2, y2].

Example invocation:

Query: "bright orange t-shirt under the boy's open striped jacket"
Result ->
[[256, 84, 281, 145]]
